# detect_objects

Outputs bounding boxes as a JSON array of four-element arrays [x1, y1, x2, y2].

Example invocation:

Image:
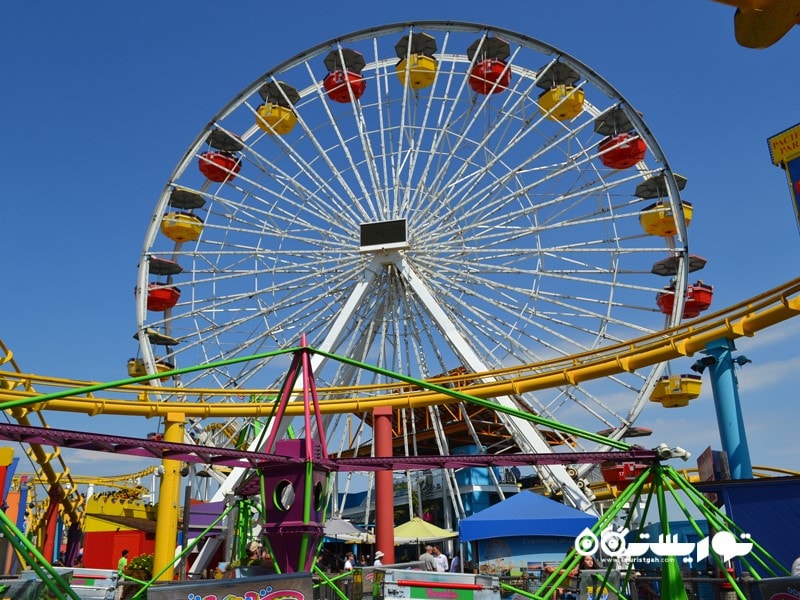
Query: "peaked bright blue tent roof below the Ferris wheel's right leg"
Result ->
[[458, 491, 597, 542]]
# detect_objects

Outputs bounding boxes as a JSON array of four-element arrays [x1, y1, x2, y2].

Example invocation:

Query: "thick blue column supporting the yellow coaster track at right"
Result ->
[[699, 338, 753, 479]]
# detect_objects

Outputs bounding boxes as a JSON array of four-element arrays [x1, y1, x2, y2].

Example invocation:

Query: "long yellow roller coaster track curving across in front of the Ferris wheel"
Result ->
[[0, 278, 800, 419]]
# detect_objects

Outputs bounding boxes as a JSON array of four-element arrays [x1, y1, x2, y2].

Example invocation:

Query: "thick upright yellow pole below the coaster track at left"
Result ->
[[153, 412, 186, 581]]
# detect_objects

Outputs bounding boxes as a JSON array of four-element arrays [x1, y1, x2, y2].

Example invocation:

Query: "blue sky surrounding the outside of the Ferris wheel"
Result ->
[[0, 0, 800, 473]]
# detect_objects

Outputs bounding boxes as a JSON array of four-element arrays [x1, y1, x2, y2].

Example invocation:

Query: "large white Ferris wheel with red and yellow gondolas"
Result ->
[[136, 22, 689, 504]]
